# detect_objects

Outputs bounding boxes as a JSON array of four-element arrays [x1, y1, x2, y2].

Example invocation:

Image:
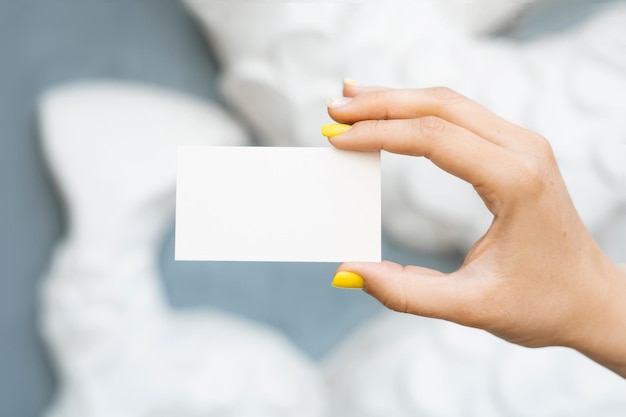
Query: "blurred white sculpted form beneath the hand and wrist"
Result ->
[[326, 313, 626, 417]]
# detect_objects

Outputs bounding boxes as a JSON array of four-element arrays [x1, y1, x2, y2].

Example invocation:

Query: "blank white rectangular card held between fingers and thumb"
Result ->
[[175, 146, 381, 262]]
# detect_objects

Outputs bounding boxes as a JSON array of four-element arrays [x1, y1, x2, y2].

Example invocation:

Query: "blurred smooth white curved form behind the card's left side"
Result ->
[[41, 82, 326, 417]]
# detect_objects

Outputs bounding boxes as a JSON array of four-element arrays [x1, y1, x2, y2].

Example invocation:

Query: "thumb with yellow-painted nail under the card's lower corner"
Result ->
[[332, 261, 471, 322]]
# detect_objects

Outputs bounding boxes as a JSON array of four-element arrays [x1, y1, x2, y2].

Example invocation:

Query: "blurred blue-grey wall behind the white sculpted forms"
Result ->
[[0, 0, 616, 417]]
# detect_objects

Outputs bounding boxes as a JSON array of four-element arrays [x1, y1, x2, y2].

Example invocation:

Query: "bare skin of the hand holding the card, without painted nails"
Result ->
[[329, 84, 626, 377]]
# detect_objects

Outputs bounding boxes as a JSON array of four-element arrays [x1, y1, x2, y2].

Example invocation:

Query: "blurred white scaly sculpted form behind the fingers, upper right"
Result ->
[[185, 0, 626, 256]]
